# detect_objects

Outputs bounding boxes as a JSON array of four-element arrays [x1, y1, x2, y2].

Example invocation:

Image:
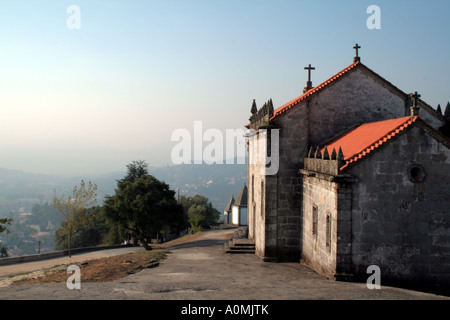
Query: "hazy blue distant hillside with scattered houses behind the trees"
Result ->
[[0, 162, 247, 217]]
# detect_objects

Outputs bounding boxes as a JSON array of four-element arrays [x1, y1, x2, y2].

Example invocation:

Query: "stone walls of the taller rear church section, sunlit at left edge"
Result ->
[[248, 61, 447, 261]]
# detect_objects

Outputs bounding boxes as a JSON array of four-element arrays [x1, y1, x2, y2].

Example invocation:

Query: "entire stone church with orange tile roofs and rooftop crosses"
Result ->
[[247, 45, 450, 292]]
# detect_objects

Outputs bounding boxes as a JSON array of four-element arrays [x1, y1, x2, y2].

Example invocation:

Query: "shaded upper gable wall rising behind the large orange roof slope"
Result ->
[[310, 68, 410, 146]]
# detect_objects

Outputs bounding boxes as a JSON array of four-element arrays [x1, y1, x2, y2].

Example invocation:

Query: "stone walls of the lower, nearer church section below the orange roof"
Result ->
[[300, 121, 450, 293]]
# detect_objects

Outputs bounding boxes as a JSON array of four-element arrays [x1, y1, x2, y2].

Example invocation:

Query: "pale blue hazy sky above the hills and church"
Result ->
[[0, 0, 450, 175]]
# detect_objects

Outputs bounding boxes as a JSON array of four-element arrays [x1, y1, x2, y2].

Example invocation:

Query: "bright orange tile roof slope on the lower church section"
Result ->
[[321, 116, 419, 170]]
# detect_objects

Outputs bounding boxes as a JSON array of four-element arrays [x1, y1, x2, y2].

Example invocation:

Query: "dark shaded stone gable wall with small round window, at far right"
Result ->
[[347, 125, 450, 288]]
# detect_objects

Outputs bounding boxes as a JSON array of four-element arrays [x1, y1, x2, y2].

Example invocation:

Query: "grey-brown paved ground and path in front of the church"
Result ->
[[0, 230, 450, 300]]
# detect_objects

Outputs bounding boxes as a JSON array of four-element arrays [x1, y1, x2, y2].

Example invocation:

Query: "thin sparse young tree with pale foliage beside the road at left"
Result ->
[[52, 180, 97, 257]]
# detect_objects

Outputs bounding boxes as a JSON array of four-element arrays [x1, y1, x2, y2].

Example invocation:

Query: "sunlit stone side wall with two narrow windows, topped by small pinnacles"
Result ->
[[300, 152, 355, 279]]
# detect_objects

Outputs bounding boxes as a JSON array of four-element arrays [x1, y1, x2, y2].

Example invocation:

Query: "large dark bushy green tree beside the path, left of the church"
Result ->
[[103, 161, 183, 250]]
